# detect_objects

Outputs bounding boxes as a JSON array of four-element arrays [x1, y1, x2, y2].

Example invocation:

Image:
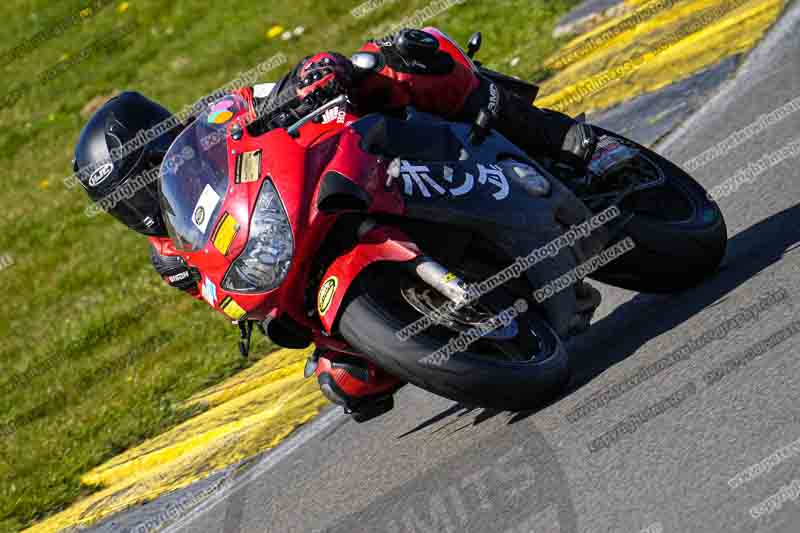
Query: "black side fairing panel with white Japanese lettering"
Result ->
[[354, 113, 591, 335]]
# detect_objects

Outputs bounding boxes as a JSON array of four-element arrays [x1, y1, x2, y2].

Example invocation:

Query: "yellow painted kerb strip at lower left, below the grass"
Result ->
[[27, 350, 327, 532]]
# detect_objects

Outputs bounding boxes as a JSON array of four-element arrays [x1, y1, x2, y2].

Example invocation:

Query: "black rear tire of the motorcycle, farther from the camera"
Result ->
[[591, 127, 728, 293]]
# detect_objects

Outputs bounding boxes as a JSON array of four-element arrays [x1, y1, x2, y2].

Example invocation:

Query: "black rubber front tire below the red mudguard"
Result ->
[[339, 263, 569, 410]]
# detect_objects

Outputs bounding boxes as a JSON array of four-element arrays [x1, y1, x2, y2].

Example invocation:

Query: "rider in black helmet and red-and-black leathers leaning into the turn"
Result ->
[[73, 28, 597, 420]]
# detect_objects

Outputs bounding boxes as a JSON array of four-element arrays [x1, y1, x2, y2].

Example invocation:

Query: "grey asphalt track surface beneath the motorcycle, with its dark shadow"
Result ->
[[99, 3, 800, 533]]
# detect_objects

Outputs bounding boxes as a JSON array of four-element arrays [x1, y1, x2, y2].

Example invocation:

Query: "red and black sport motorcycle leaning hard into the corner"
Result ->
[[153, 30, 727, 420]]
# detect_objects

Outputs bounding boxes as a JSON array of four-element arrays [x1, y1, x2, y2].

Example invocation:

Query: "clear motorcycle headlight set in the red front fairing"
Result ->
[[222, 179, 294, 293]]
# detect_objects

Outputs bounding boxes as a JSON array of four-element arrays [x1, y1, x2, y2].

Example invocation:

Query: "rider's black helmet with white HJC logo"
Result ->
[[73, 92, 182, 236]]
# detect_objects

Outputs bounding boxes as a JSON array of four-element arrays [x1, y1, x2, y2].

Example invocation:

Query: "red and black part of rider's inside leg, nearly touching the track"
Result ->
[[306, 349, 404, 422]]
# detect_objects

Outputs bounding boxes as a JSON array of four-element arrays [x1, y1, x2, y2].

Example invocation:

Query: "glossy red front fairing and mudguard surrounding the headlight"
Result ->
[[168, 91, 420, 338]]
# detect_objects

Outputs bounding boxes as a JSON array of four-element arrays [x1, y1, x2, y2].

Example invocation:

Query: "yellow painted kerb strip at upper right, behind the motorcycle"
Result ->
[[536, 0, 785, 115]]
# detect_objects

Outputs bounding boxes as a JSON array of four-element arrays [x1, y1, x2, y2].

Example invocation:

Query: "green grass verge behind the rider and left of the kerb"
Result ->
[[0, 0, 575, 531]]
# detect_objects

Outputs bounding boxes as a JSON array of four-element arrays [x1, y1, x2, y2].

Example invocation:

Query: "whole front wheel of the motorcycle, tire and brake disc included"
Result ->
[[339, 264, 569, 410]]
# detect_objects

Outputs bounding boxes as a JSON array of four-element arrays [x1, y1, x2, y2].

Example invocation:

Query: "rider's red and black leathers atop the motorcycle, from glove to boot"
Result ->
[[234, 28, 595, 166]]
